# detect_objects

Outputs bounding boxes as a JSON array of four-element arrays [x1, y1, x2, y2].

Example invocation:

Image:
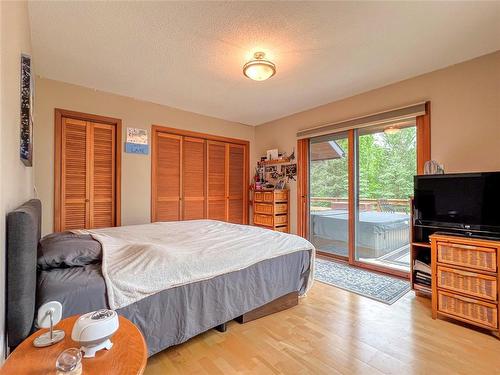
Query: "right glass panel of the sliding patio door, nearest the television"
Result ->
[[354, 121, 417, 272]]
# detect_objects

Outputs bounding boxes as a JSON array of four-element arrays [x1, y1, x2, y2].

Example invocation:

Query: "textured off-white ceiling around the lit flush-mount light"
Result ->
[[29, 1, 500, 125]]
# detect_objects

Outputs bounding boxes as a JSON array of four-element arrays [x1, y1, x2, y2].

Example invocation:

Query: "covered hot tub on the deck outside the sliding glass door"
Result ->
[[311, 210, 410, 258]]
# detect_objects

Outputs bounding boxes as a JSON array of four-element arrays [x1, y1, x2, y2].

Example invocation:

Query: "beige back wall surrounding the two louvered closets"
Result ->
[[34, 78, 255, 234]]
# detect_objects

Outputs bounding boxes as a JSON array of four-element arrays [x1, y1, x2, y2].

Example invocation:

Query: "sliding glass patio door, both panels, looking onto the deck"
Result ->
[[309, 119, 417, 274]]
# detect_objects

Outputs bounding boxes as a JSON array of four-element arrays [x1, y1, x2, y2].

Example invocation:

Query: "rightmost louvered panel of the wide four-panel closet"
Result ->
[[226, 143, 246, 224]]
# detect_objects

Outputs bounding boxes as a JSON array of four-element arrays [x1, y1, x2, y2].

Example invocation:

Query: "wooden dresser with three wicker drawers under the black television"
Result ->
[[430, 234, 500, 337]]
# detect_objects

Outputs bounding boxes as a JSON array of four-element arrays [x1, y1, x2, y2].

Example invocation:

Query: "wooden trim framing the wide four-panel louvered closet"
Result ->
[[151, 125, 250, 224]]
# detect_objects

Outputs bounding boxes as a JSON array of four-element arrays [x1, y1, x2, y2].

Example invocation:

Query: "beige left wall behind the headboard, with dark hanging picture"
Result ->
[[0, 1, 33, 362]]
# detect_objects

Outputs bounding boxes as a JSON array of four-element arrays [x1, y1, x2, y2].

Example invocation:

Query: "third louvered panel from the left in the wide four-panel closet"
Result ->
[[207, 141, 227, 221]]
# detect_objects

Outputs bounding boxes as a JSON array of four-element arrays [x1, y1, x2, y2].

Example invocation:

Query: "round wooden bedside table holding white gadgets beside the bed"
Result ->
[[0, 315, 148, 375]]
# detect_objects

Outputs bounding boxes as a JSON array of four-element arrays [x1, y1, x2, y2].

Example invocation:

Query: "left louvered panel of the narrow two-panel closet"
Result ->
[[61, 118, 90, 230]]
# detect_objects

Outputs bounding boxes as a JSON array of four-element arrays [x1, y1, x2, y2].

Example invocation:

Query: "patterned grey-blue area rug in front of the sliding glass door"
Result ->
[[314, 259, 410, 305]]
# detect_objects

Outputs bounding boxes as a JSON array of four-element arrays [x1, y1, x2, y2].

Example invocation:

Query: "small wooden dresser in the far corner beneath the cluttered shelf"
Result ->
[[253, 189, 290, 233]]
